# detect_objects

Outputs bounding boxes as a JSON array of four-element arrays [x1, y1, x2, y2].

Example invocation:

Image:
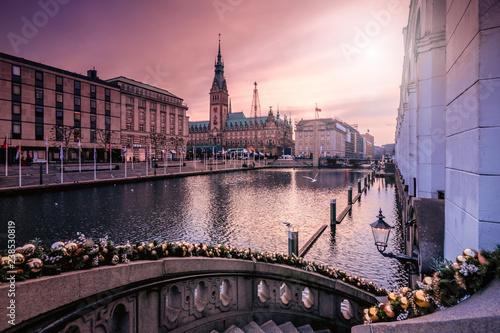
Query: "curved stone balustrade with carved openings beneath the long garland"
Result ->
[[0, 257, 376, 333]]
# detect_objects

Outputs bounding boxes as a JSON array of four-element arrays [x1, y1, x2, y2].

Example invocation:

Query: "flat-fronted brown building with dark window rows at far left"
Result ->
[[0, 53, 121, 163]]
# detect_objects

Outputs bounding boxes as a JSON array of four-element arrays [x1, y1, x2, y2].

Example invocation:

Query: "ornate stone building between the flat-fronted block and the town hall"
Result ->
[[107, 76, 189, 161]]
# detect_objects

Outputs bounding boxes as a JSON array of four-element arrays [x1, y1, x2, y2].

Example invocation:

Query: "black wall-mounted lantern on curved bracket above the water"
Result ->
[[370, 209, 419, 285]]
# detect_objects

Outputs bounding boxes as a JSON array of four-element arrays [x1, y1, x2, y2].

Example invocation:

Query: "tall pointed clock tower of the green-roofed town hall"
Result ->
[[209, 34, 229, 145]]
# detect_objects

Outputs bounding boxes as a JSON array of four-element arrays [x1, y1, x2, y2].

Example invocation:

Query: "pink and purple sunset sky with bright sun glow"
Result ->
[[0, 0, 410, 146]]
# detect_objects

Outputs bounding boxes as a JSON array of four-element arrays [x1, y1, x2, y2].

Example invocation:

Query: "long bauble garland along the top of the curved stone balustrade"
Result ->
[[0, 233, 387, 296]]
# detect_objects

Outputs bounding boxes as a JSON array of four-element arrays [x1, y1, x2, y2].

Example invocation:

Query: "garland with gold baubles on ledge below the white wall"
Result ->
[[363, 244, 500, 324]]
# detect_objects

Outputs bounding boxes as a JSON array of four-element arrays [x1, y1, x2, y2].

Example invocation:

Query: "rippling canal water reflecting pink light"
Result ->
[[0, 169, 406, 289]]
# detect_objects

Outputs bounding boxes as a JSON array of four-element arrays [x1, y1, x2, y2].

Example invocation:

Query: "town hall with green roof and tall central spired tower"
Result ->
[[188, 40, 293, 155]]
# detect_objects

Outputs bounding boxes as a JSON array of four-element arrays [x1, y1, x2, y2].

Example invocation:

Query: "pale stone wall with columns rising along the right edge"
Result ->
[[395, 0, 500, 259]]
